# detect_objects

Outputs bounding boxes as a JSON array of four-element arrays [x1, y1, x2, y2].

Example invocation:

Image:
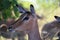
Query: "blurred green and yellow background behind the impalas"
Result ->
[[0, 0, 60, 40]]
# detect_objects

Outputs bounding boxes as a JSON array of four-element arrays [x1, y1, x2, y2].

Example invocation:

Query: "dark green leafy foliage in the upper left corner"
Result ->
[[0, 0, 19, 19]]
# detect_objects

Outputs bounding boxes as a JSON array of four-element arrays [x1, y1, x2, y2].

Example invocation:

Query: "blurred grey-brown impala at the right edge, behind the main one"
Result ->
[[41, 16, 60, 40]]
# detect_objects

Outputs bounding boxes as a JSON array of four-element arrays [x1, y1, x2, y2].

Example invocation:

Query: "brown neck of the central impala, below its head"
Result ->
[[28, 20, 42, 40]]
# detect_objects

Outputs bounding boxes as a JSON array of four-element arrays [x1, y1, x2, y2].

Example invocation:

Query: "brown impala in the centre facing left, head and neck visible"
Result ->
[[8, 4, 42, 40]]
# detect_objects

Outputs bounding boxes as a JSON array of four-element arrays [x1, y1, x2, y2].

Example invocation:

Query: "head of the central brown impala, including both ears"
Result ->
[[8, 4, 41, 31]]
